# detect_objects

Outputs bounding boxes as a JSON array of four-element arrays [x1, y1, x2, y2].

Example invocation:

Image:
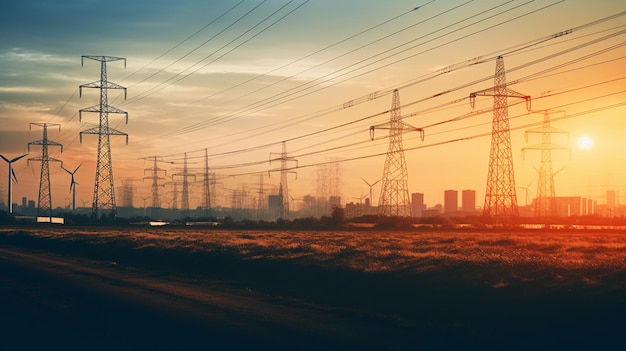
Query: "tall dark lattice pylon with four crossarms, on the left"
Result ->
[[79, 56, 128, 220]]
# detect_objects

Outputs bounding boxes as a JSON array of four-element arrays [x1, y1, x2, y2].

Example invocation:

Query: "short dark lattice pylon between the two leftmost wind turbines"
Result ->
[[28, 123, 63, 223]]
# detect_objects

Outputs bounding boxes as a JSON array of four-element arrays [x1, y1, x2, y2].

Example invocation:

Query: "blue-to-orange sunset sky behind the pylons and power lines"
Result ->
[[0, 0, 626, 212]]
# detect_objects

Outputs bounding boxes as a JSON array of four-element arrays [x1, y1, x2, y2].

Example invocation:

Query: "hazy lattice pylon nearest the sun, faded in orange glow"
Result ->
[[522, 110, 570, 218]]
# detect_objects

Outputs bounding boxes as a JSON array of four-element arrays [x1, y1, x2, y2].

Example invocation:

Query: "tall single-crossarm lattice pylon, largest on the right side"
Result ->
[[470, 56, 530, 222]]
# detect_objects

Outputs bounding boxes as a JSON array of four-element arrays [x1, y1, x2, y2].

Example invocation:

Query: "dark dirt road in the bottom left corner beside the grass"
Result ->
[[0, 249, 392, 350]]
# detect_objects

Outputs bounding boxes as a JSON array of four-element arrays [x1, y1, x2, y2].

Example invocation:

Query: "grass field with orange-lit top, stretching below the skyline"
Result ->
[[0, 227, 626, 349]]
